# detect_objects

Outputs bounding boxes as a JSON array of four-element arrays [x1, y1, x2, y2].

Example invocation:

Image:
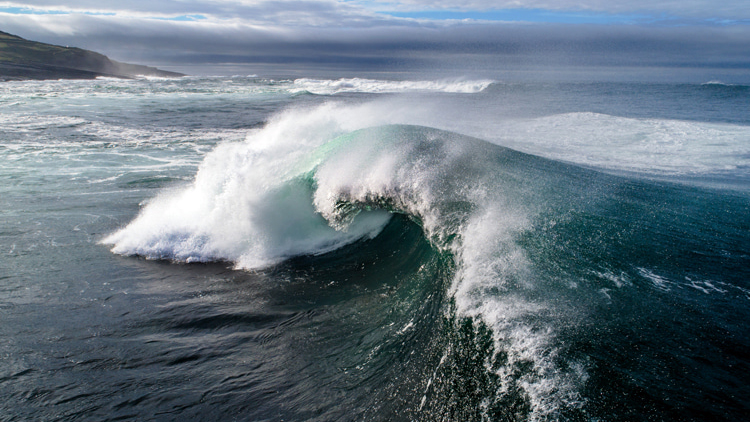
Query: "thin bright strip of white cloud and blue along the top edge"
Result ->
[[8, 0, 750, 22]]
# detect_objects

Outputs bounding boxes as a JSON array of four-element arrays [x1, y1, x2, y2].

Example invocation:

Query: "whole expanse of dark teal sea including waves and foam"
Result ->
[[0, 77, 750, 421]]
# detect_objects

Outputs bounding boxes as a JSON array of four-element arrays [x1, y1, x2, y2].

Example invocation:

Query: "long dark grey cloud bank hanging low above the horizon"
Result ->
[[0, 10, 750, 67]]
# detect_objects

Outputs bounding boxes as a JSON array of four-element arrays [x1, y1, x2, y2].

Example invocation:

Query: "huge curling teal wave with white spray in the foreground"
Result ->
[[102, 100, 750, 420]]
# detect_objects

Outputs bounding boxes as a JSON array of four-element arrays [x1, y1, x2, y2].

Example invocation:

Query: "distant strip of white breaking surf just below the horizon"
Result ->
[[291, 78, 494, 95]]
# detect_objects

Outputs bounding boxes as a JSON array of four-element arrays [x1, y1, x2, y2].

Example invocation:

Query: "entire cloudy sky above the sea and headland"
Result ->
[[0, 0, 750, 77]]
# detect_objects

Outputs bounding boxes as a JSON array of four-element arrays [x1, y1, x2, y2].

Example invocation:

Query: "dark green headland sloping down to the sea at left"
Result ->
[[0, 31, 184, 80]]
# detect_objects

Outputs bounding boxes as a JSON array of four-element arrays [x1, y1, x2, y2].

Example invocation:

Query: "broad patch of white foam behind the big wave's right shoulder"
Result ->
[[477, 113, 750, 175]]
